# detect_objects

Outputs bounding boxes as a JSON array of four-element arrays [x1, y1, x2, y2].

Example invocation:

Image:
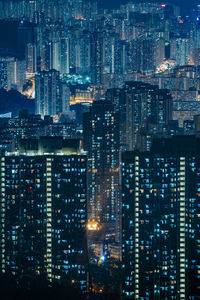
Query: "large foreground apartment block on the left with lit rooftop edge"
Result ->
[[0, 138, 87, 291]]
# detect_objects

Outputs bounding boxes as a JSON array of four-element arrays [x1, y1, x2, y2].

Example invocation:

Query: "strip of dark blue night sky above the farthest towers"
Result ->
[[99, 0, 200, 12]]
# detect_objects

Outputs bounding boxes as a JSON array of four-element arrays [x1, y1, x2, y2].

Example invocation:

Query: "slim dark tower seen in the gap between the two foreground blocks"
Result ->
[[83, 100, 120, 240]]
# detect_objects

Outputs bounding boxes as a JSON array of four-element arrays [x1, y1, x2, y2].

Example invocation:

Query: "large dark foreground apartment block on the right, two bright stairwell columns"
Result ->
[[122, 136, 200, 299]]
